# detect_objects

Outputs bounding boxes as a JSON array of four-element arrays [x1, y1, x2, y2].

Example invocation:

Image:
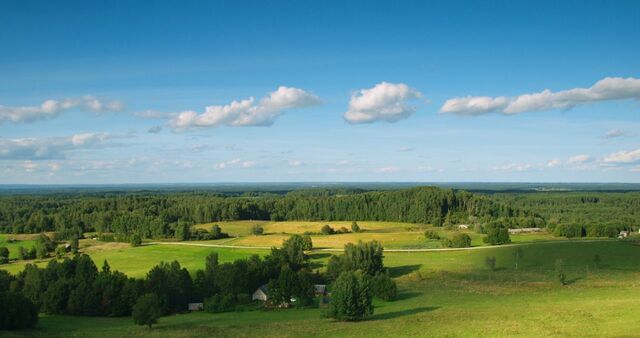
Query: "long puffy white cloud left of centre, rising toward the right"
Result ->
[[169, 86, 320, 131]]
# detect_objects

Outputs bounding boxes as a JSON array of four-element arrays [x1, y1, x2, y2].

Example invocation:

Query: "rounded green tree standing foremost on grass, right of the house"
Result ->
[[327, 271, 373, 321]]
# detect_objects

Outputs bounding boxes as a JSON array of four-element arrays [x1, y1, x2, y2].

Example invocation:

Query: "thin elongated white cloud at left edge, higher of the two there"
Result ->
[[0, 96, 124, 124]]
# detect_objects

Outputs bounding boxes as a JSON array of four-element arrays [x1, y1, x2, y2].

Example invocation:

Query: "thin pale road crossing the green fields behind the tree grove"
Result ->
[[148, 239, 617, 252]]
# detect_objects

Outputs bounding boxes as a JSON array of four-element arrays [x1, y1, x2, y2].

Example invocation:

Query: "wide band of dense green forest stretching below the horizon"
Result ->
[[0, 187, 640, 239]]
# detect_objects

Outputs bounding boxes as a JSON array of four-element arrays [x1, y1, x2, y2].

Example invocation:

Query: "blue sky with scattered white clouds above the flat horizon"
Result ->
[[0, 0, 640, 184]]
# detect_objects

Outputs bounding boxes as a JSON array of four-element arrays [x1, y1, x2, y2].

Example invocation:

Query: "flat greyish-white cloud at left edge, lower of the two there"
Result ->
[[0, 133, 131, 160]]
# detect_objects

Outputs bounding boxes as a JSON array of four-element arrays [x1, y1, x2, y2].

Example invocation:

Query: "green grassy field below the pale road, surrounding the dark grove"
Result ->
[[2, 241, 640, 337]]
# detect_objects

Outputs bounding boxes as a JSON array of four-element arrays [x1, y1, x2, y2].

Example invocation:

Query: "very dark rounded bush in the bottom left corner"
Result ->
[[0, 292, 38, 330]]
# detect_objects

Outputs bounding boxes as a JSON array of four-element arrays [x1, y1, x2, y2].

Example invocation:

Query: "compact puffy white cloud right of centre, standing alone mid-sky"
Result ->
[[344, 82, 422, 124]]
